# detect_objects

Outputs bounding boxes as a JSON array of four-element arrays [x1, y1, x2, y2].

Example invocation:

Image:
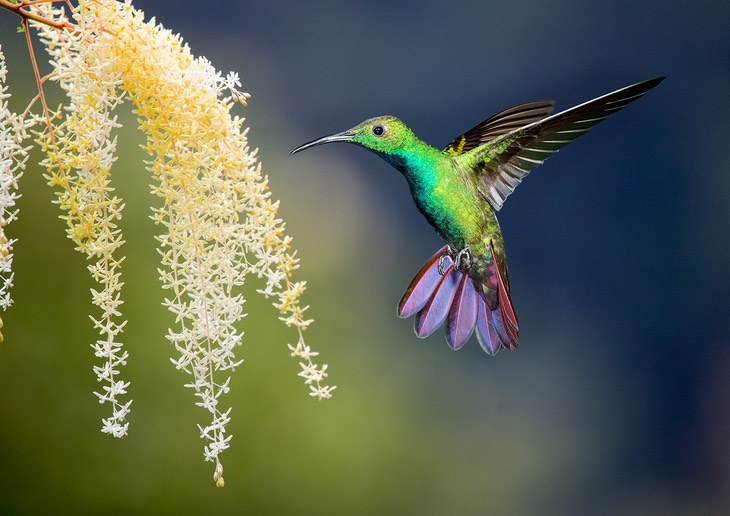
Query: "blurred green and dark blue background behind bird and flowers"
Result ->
[[0, 0, 730, 515]]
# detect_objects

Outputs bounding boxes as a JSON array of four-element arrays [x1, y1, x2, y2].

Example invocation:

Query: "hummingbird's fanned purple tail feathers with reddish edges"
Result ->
[[398, 246, 518, 355]]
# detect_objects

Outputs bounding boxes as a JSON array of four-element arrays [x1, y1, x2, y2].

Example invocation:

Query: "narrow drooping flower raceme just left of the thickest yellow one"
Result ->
[[36, 13, 131, 437]]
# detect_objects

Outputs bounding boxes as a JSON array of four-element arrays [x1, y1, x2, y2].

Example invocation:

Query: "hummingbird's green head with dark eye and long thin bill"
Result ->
[[292, 116, 414, 156]]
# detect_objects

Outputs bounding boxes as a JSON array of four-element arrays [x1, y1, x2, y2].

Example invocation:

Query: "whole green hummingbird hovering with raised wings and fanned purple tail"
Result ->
[[292, 77, 665, 355]]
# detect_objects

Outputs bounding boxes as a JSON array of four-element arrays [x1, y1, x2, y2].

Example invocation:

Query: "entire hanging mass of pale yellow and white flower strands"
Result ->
[[0, 0, 334, 486]]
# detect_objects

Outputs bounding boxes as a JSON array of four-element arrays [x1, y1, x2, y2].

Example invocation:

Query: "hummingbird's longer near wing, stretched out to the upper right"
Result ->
[[460, 77, 665, 210]]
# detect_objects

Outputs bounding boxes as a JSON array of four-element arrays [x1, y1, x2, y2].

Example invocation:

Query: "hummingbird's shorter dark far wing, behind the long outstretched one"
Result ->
[[444, 100, 555, 156]]
